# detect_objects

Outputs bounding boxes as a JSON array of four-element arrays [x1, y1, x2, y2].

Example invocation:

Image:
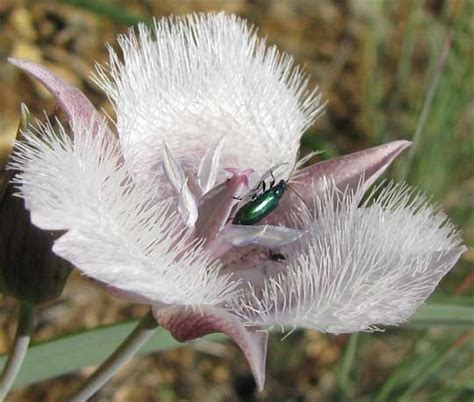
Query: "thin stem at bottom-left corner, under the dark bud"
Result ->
[[0, 302, 35, 401]]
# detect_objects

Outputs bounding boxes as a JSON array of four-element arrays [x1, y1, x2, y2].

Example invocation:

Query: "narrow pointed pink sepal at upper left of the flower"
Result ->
[[8, 57, 104, 133]]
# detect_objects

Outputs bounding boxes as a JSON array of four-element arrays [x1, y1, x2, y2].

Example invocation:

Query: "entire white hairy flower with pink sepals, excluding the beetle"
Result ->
[[11, 14, 465, 389]]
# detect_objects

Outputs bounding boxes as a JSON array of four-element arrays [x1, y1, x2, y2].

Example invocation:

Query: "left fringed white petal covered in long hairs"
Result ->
[[11, 124, 241, 305]]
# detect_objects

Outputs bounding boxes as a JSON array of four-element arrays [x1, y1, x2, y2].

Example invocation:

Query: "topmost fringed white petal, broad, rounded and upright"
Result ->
[[95, 13, 321, 183]]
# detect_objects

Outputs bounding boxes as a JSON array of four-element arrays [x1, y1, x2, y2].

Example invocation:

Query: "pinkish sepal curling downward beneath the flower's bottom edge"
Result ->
[[153, 306, 268, 391]]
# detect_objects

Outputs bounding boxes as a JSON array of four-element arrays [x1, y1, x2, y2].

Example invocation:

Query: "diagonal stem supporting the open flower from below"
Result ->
[[70, 309, 158, 402]]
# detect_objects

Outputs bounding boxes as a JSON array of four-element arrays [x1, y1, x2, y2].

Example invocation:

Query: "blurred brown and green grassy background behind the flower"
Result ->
[[0, 0, 474, 402]]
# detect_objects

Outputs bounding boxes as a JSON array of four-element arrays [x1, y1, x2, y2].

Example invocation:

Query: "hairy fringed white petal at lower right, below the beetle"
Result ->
[[232, 184, 466, 333]]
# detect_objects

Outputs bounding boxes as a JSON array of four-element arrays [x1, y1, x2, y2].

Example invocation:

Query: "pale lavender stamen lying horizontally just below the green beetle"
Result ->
[[219, 225, 304, 248]]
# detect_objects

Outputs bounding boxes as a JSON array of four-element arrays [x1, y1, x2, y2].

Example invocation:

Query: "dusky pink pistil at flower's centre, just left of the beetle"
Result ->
[[195, 170, 250, 241]]
